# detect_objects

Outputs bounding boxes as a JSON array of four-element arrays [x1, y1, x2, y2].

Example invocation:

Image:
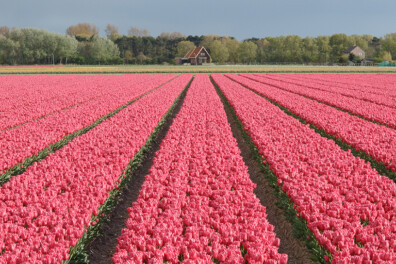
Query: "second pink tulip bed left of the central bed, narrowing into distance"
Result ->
[[0, 75, 176, 171]]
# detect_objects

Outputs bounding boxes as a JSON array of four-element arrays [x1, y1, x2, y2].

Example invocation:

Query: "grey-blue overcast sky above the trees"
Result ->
[[0, 0, 396, 40]]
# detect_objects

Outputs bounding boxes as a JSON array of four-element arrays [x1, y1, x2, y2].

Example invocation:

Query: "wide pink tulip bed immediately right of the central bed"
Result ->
[[212, 74, 396, 263]]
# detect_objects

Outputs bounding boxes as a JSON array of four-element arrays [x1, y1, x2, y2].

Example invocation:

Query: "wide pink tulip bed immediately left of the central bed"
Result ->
[[0, 74, 191, 263]]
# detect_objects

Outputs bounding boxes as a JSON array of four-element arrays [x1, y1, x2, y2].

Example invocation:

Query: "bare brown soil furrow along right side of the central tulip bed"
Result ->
[[215, 81, 313, 264]]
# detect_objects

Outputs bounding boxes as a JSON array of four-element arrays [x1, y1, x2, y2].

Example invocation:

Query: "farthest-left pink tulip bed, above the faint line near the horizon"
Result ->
[[0, 75, 172, 131]]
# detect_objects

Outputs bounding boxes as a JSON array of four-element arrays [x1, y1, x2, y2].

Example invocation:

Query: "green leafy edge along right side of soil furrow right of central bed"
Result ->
[[210, 77, 332, 264]]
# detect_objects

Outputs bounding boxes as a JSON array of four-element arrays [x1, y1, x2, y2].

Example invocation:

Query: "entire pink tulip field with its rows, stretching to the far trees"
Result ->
[[0, 73, 396, 264]]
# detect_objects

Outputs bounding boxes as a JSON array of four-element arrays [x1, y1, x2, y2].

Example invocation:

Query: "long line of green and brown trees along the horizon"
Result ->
[[0, 23, 396, 65]]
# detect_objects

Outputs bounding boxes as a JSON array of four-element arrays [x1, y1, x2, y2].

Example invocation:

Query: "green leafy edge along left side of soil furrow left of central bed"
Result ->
[[62, 77, 194, 264]]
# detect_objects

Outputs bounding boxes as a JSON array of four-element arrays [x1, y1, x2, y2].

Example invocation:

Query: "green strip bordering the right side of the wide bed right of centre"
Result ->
[[230, 75, 396, 180]]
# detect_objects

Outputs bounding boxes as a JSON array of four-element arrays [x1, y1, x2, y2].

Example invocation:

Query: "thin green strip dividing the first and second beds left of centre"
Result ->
[[0, 76, 178, 186]]
